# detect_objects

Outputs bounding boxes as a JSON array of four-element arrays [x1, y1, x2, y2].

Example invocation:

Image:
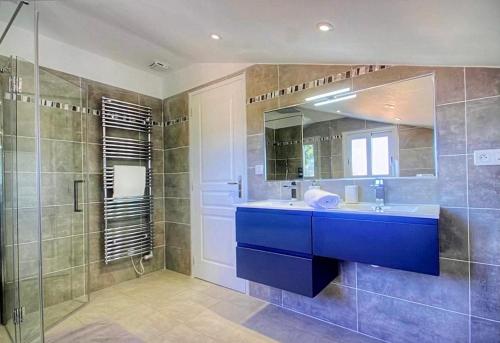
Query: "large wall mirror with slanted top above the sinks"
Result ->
[[264, 75, 436, 180]]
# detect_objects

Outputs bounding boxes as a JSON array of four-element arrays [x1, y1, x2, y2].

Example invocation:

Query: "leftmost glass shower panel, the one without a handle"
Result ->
[[1, 57, 42, 342]]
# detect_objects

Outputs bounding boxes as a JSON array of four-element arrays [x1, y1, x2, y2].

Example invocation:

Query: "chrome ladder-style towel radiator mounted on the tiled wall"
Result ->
[[101, 97, 153, 264]]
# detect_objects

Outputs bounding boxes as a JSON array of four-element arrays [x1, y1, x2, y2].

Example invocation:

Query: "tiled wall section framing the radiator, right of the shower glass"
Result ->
[[83, 76, 165, 291]]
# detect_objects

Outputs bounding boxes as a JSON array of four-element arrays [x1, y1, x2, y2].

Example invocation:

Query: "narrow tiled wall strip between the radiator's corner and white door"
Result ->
[[163, 93, 191, 275]]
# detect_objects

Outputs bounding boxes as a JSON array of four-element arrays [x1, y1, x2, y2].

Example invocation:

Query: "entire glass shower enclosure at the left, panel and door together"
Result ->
[[0, 2, 89, 342]]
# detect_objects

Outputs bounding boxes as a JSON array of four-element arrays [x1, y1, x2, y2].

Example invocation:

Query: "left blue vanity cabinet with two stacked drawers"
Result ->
[[236, 207, 338, 297]]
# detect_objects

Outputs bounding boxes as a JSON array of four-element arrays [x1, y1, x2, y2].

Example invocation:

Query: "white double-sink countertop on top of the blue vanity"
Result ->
[[238, 200, 439, 219]]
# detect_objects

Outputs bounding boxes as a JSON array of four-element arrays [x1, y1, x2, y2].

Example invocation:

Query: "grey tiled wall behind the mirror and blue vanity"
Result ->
[[246, 65, 500, 342]]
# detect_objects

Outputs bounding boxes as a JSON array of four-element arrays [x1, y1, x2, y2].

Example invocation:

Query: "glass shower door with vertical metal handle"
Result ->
[[40, 67, 88, 335]]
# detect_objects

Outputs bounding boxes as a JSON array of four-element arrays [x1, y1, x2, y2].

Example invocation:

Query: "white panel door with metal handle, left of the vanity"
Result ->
[[189, 75, 246, 292]]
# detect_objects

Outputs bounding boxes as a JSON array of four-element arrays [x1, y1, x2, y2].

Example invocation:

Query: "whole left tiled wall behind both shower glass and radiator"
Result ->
[[2, 56, 165, 328]]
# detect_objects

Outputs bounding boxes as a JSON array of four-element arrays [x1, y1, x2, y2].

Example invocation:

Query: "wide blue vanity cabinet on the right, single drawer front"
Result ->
[[312, 212, 439, 275]]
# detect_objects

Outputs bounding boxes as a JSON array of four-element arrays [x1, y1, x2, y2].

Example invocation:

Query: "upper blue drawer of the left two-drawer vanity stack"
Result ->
[[236, 208, 312, 254]]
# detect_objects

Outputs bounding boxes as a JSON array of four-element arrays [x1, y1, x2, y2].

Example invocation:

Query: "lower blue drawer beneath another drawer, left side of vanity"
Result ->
[[236, 247, 338, 297]]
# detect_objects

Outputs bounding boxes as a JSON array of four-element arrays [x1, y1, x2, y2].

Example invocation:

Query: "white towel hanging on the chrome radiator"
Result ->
[[113, 166, 146, 198]]
